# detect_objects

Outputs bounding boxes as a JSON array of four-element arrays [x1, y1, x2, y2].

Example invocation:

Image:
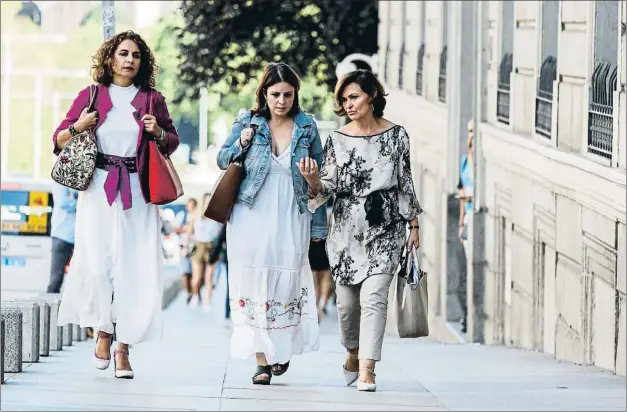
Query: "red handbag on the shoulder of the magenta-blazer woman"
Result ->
[[148, 92, 183, 205]]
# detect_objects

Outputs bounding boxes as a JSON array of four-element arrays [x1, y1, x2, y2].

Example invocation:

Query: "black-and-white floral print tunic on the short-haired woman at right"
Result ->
[[309, 125, 422, 285]]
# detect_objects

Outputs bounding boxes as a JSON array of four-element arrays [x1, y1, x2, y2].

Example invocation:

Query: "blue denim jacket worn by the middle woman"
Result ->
[[218, 111, 327, 238]]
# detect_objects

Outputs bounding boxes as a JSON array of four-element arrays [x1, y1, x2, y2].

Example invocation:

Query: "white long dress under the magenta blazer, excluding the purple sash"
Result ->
[[59, 84, 163, 344]]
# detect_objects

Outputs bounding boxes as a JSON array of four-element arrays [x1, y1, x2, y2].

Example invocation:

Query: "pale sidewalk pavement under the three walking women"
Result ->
[[1, 281, 626, 411]]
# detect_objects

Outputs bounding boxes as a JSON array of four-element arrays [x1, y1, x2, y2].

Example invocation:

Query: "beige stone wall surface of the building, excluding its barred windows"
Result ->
[[380, 1, 627, 375]]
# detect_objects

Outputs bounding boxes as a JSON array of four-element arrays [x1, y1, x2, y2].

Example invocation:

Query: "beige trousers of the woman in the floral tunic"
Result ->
[[336, 274, 392, 361]]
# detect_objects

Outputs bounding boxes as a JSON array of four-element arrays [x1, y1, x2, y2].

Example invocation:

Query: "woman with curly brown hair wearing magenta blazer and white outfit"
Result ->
[[53, 31, 179, 379]]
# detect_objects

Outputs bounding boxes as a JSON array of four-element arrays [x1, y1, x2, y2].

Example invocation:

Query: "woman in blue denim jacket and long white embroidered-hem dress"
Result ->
[[218, 63, 327, 385]]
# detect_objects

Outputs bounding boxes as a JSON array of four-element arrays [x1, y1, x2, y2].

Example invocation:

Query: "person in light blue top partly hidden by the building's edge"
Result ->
[[457, 120, 475, 333]]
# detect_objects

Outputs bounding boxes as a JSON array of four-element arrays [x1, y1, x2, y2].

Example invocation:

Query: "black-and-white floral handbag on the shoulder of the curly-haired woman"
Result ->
[[52, 85, 98, 191]]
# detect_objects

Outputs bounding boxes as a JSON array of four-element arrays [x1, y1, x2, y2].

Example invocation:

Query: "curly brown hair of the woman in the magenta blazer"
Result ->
[[91, 30, 158, 90]]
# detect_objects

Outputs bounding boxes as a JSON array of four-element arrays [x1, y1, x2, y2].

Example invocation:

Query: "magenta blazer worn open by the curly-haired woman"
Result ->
[[52, 84, 180, 202]]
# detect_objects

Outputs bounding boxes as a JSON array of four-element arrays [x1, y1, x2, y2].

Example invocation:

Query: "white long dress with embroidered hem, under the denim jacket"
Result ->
[[227, 148, 319, 364]]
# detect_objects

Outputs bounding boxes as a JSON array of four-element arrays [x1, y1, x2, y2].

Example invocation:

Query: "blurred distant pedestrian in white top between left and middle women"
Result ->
[[187, 193, 223, 312]]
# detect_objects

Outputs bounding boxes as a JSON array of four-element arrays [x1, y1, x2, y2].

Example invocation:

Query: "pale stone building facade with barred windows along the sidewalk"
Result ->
[[377, 1, 627, 375]]
